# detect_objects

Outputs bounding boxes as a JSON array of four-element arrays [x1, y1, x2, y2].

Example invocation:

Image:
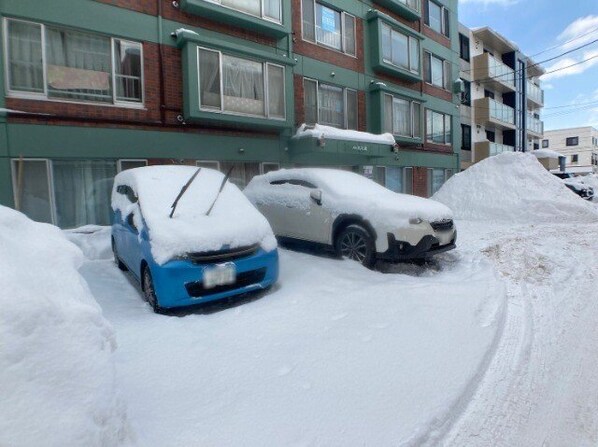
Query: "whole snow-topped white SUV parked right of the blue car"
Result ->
[[244, 168, 457, 267]]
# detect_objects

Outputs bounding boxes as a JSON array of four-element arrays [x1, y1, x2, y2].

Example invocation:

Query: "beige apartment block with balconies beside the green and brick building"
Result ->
[[459, 24, 544, 169]]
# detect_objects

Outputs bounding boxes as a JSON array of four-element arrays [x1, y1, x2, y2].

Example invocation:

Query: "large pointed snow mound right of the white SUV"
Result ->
[[432, 152, 598, 223]]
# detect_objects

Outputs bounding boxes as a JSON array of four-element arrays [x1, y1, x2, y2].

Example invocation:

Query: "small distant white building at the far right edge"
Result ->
[[542, 126, 598, 174]]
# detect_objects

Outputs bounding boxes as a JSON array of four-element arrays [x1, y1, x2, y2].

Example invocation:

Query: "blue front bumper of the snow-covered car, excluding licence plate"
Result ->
[[151, 249, 278, 308]]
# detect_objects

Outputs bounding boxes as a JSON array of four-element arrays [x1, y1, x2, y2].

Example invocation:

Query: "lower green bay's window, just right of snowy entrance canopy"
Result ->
[[384, 94, 421, 138]]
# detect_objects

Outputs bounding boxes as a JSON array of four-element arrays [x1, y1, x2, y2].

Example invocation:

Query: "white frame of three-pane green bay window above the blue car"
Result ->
[[196, 45, 287, 121]]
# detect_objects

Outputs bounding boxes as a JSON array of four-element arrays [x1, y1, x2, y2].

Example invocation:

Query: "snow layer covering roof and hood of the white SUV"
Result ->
[[244, 168, 452, 221]]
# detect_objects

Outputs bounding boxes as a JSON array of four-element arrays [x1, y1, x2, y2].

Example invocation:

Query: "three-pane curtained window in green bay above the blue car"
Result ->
[[197, 48, 285, 119]]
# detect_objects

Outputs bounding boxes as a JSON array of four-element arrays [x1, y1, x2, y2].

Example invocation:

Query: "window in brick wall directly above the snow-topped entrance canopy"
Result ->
[[303, 78, 357, 130]]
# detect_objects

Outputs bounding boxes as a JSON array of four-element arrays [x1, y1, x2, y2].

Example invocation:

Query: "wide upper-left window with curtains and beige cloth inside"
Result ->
[[5, 19, 143, 104]]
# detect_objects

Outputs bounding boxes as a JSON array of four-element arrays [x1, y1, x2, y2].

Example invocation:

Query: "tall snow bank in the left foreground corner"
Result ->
[[0, 206, 128, 446]]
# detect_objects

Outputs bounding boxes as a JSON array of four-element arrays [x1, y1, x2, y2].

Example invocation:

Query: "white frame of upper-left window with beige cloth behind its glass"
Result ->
[[2, 17, 145, 109]]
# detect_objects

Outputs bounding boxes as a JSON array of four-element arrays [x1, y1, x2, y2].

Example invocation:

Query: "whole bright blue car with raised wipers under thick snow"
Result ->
[[112, 166, 278, 311]]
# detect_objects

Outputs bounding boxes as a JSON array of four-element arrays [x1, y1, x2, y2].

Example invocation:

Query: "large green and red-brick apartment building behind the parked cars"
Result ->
[[0, 0, 461, 228]]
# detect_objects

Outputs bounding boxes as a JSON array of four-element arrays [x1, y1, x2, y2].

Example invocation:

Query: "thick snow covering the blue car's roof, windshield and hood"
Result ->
[[112, 166, 276, 264]]
